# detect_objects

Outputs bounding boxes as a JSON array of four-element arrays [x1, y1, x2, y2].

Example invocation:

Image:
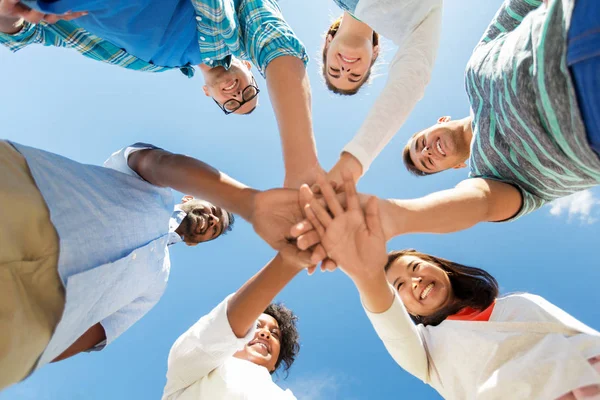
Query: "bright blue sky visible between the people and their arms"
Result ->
[[0, 0, 600, 400]]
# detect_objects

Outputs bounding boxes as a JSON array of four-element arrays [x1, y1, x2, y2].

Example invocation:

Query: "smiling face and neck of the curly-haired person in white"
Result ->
[[233, 314, 281, 372]]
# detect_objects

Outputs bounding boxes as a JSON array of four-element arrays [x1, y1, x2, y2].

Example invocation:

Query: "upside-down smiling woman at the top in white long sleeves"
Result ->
[[322, 0, 442, 188]]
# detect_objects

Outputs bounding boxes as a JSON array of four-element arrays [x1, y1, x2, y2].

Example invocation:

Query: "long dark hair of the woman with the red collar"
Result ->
[[385, 249, 499, 326]]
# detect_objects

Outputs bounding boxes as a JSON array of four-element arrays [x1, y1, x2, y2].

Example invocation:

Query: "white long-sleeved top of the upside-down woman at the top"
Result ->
[[344, 0, 442, 172]]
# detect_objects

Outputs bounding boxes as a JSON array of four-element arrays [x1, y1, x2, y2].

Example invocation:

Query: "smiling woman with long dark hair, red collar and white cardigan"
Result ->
[[302, 176, 600, 400]]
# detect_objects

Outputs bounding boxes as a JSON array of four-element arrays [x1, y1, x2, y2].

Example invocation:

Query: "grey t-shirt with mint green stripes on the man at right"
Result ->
[[465, 0, 600, 219]]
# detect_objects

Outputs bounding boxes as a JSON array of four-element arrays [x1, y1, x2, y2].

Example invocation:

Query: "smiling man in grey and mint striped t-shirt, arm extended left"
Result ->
[[396, 0, 600, 228]]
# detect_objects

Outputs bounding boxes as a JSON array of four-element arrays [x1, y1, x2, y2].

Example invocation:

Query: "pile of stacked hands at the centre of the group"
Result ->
[[251, 173, 387, 279]]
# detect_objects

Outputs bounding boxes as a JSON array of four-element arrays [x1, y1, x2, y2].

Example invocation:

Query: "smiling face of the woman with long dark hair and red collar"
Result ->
[[386, 255, 454, 317]]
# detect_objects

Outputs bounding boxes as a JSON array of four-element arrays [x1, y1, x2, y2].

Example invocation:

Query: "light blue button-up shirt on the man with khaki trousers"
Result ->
[[12, 143, 182, 368]]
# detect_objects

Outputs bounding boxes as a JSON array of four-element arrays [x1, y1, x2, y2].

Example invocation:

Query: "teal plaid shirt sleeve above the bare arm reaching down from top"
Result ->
[[241, 0, 308, 77]]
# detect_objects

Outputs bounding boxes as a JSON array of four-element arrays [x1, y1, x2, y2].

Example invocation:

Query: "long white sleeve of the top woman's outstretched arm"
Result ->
[[344, 7, 442, 172]]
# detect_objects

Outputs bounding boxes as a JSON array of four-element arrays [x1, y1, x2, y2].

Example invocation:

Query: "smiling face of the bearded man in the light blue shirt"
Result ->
[[175, 196, 229, 246]]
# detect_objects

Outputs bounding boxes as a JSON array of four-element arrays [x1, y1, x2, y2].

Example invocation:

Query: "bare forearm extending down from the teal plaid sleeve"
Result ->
[[265, 56, 320, 188]]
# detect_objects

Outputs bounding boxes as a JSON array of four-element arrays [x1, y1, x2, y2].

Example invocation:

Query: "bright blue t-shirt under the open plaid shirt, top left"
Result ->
[[24, 0, 202, 67]]
